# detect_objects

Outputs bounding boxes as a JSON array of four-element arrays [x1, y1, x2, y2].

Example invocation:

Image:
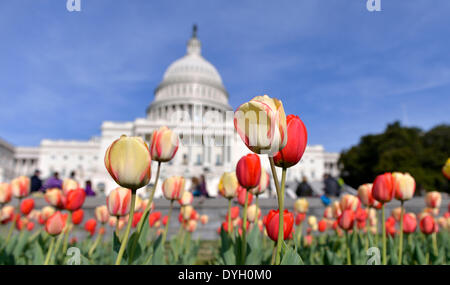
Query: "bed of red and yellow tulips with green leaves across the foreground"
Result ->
[[0, 95, 450, 265]]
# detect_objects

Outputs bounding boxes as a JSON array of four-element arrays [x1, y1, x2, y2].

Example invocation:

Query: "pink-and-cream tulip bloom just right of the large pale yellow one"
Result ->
[[150, 126, 179, 162]]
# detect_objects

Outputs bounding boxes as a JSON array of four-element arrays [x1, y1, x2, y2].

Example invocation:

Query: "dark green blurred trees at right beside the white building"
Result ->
[[339, 122, 450, 192]]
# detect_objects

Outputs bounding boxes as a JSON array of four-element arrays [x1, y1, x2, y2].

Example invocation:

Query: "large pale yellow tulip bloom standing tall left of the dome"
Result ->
[[105, 135, 152, 191]]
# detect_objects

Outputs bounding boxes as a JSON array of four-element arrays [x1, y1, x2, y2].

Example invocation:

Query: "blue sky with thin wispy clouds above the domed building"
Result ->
[[0, 0, 450, 151]]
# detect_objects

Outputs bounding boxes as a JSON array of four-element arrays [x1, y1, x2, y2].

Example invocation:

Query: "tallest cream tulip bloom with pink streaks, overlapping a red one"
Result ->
[[234, 95, 287, 156]]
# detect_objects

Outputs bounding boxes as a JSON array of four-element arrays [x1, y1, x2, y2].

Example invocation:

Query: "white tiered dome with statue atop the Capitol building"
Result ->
[[147, 26, 231, 119]]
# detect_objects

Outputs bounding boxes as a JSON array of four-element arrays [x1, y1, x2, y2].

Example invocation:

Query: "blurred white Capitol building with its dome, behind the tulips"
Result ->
[[0, 27, 339, 196]]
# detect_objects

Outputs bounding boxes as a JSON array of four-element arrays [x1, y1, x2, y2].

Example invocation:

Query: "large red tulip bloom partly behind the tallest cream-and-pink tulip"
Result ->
[[273, 115, 308, 168]]
